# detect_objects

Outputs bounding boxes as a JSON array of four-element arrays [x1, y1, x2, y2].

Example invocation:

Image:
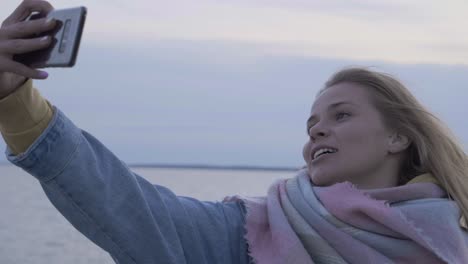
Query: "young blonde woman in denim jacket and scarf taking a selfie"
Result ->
[[0, 1, 468, 264]]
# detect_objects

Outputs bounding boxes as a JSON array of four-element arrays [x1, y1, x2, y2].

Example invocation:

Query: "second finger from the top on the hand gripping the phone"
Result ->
[[0, 18, 57, 39]]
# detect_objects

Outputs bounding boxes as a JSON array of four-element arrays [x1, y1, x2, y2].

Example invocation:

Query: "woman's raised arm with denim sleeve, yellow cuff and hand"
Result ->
[[0, 1, 248, 263]]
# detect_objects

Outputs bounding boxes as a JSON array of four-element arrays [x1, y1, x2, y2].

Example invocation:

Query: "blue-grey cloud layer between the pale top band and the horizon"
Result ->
[[0, 40, 468, 166]]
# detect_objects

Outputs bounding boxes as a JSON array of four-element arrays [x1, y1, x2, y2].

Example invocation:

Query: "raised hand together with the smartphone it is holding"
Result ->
[[0, 0, 86, 99]]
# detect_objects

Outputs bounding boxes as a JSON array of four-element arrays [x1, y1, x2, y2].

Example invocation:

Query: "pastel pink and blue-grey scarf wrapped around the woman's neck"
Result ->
[[225, 170, 468, 264]]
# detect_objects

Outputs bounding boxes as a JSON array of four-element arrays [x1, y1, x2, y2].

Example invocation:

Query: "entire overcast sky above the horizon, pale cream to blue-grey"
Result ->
[[0, 0, 468, 166]]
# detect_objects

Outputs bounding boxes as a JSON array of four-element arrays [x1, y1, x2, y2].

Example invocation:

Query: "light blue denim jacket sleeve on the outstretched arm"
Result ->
[[6, 107, 252, 264]]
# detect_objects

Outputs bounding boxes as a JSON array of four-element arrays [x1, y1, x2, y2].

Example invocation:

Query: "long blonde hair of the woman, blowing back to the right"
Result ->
[[319, 68, 468, 218]]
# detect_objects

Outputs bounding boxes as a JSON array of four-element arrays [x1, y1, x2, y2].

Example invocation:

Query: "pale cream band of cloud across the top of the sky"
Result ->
[[1, 0, 468, 64]]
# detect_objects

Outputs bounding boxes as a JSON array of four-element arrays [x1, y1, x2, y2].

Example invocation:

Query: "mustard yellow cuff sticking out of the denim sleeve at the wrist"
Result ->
[[0, 79, 53, 154]]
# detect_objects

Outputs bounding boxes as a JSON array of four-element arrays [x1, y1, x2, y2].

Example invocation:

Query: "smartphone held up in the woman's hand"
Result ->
[[13, 6, 87, 68]]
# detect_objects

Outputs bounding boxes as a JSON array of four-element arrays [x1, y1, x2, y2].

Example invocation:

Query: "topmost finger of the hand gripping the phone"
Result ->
[[2, 0, 54, 26]]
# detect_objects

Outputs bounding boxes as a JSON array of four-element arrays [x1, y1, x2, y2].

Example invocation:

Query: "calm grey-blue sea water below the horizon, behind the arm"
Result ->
[[0, 165, 294, 264]]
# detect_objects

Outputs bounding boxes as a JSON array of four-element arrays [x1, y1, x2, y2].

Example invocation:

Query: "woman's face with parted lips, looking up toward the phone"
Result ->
[[303, 83, 396, 188]]
